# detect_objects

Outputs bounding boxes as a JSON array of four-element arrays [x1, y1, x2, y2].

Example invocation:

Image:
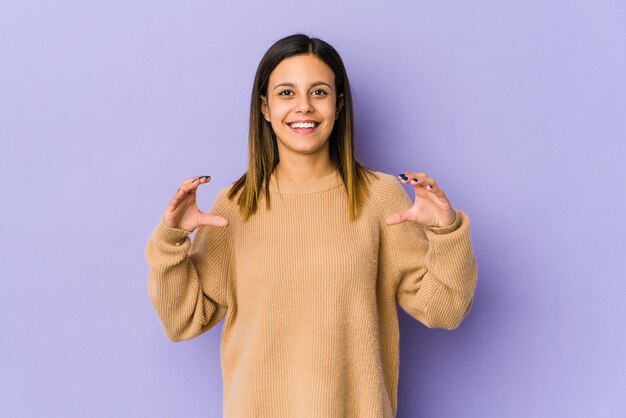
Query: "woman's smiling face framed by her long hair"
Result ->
[[261, 54, 342, 159]]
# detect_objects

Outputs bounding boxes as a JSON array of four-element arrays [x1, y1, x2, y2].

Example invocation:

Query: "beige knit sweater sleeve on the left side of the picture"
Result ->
[[145, 189, 231, 342]]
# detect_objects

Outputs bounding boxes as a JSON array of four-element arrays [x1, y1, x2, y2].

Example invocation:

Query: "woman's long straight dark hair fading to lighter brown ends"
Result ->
[[228, 34, 375, 221]]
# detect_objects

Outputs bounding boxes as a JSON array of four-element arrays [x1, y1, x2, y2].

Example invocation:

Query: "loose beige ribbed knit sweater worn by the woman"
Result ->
[[145, 171, 477, 418]]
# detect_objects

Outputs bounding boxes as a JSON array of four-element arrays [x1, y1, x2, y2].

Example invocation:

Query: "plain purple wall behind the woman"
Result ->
[[0, 0, 626, 418]]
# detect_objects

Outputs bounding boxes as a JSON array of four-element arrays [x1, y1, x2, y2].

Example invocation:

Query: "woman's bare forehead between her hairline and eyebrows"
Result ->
[[269, 54, 335, 85]]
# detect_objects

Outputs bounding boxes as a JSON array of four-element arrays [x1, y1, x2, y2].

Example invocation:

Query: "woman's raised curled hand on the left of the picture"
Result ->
[[163, 176, 228, 232]]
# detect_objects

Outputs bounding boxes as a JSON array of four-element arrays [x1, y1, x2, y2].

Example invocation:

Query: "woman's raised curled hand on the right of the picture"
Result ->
[[386, 171, 456, 227]]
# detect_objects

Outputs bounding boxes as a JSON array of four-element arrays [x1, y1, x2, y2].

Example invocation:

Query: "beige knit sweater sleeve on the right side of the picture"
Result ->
[[383, 178, 477, 330]]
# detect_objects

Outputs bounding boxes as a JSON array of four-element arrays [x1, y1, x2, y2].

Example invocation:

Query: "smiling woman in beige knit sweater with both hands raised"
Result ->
[[146, 34, 477, 418]]
